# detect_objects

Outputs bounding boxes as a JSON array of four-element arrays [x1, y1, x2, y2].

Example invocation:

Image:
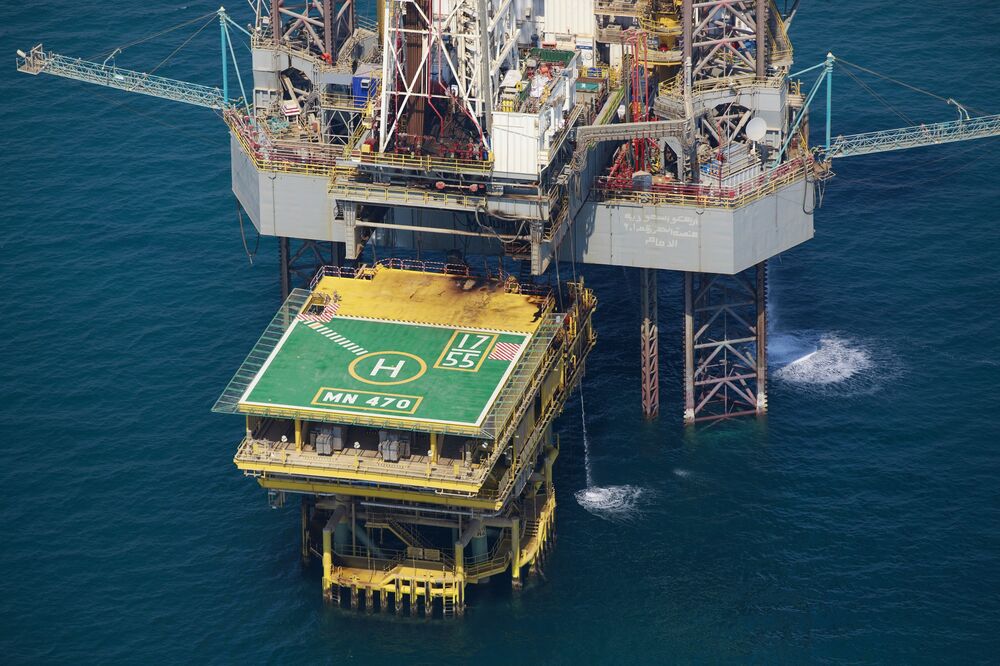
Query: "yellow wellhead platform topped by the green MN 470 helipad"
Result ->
[[215, 261, 596, 616]]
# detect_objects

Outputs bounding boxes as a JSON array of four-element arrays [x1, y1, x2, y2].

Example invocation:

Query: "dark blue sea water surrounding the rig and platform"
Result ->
[[0, 0, 1000, 664]]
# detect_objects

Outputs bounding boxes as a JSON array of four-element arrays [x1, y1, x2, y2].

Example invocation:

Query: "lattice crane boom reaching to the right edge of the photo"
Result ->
[[825, 115, 1000, 159]]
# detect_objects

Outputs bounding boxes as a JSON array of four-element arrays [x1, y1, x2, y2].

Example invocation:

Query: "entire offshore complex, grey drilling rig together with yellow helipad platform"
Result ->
[[18, 0, 1000, 616]]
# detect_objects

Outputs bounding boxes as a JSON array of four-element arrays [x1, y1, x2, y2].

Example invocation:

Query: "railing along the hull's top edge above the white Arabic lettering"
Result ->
[[591, 158, 813, 209]]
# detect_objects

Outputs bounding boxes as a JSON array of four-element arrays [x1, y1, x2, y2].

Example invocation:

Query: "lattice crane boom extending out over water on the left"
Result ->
[[17, 44, 227, 110]]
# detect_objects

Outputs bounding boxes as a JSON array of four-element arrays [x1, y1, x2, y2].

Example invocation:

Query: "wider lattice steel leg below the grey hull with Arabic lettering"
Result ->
[[684, 262, 767, 424]]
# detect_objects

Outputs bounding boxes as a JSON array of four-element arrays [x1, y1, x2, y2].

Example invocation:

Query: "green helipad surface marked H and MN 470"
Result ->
[[239, 317, 531, 426]]
